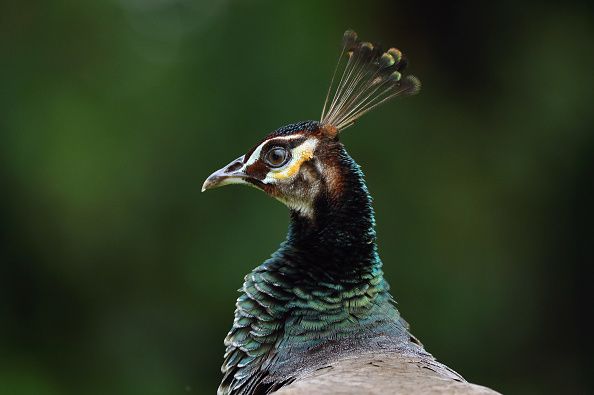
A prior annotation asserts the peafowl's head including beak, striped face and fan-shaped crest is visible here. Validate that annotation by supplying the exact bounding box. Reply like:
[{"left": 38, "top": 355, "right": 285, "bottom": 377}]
[{"left": 202, "top": 30, "right": 420, "bottom": 217}]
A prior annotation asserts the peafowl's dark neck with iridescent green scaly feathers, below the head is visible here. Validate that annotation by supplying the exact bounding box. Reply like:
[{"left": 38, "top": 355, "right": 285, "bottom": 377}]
[{"left": 219, "top": 150, "right": 409, "bottom": 393}]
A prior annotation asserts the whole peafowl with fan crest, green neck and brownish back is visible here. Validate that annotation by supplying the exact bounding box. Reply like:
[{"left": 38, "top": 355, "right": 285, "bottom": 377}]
[{"left": 202, "top": 30, "right": 496, "bottom": 395}]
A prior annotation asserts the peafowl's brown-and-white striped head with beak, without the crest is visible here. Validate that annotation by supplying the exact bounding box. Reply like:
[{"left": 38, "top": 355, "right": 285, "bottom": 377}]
[{"left": 202, "top": 121, "right": 341, "bottom": 216}]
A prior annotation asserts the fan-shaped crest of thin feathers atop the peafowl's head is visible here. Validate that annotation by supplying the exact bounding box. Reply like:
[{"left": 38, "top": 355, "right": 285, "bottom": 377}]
[{"left": 321, "top": 30, "right": 421, "bottom": 133}]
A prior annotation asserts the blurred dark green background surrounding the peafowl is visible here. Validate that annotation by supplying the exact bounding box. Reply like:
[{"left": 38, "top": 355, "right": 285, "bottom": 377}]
[{"left": 0, "top": 0, "right": 594, "bottom": 395}]
